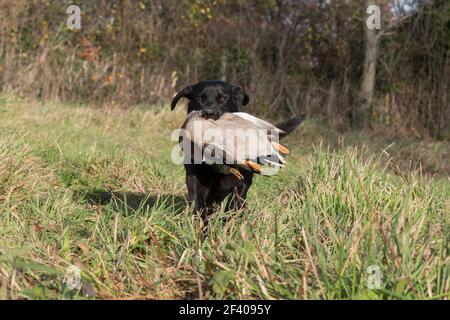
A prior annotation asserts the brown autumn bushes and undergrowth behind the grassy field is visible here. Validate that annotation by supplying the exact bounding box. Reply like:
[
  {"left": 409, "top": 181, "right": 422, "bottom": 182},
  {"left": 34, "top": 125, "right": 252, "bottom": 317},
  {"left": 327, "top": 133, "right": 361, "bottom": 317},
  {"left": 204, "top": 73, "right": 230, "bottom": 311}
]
[{"left": 0, "top": 0, "right": 450, "bottom": 138}]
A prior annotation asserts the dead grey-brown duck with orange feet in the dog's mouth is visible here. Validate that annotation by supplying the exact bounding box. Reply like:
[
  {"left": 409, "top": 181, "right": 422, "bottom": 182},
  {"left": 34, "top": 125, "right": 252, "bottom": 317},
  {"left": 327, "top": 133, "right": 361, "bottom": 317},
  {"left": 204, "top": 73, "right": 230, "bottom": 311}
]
[{"left": 180, "top": 111, "right": 289, "bottom": 179}]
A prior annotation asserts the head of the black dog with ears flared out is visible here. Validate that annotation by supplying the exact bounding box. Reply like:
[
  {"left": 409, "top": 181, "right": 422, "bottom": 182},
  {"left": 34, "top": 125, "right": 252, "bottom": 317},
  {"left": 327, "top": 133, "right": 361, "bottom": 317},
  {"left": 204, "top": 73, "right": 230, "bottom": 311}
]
[{"left": 171, "top": 80, "right": 250, "bottom": 120}]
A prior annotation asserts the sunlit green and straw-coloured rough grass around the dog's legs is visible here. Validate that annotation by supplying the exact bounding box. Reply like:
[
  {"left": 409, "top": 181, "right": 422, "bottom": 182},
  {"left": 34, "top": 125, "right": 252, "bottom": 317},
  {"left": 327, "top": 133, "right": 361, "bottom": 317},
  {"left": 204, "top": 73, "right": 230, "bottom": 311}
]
[{"left": 0, "top": 96, "right": 450, "bottom": 299}]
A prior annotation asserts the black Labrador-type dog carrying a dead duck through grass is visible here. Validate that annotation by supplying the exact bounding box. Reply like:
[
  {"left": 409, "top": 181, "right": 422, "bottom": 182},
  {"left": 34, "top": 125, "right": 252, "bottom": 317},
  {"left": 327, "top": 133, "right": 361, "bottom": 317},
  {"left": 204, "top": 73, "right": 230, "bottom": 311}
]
[{"left": 171, "top": 80, "right": 303, "bottom": 219}]
